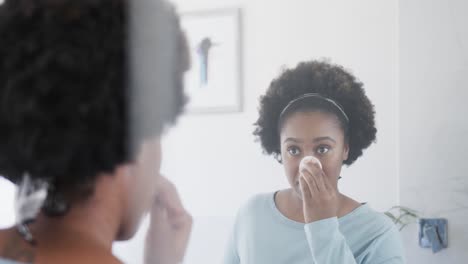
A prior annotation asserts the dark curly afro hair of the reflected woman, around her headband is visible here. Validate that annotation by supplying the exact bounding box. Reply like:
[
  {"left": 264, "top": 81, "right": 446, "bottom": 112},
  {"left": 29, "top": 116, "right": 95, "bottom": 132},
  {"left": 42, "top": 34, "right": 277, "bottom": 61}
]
[{"left": 253, "top": 60, "right": 377, "bottom": 165}]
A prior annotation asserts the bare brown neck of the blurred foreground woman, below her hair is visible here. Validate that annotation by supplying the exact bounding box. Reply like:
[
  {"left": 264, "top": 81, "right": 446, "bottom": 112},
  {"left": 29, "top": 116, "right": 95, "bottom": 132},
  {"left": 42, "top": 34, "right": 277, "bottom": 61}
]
[{"left": 31, "top": 176, "right": 122, "bottom": 251}]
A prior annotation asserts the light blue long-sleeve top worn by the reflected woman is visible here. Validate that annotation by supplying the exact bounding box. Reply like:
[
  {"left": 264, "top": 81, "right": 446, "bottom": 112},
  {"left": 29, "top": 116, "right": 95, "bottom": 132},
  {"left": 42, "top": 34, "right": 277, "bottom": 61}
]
[{"left": 224, "top": 193, "right": 405, "bottom": 264}]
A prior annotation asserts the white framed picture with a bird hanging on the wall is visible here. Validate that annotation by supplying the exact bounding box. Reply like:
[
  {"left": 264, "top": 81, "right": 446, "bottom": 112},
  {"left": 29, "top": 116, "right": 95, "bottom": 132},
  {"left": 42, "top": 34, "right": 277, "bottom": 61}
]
[{"left": 181, "top": 8, "right": 242, "bottom": 113}]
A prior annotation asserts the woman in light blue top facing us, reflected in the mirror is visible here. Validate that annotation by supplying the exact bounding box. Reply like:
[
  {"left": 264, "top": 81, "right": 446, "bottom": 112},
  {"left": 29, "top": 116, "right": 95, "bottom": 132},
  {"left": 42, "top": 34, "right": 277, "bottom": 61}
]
[{"left": 224, "top": 61, "right": 404, "bottom": 264}]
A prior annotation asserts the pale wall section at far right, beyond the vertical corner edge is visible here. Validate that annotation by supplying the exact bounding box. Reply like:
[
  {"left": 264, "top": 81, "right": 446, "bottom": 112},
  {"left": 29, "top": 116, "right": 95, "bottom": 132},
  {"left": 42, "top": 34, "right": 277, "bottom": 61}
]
[{"left": 399, "top": 0, "right": 468, "bottom": 264}]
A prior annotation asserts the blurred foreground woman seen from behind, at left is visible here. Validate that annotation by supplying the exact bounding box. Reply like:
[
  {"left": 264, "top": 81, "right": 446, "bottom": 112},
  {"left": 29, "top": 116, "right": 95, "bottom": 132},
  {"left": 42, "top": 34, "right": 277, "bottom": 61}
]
[{"left": 0, "top": 0, "right": 191, "bottom": 264}]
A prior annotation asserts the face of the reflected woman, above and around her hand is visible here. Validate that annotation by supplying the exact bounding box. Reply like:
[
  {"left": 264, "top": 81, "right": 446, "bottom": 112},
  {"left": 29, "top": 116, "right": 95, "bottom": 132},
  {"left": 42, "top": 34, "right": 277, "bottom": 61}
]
[{"left": 280, "top": 111, "right": 349, "bottom": 198}]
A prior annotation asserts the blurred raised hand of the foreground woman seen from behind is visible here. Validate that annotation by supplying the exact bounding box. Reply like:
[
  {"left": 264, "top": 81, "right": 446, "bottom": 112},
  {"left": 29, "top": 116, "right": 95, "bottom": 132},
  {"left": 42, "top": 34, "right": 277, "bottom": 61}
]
[{"left": 145, "top": 176, "right": 192, "bottom": 264}]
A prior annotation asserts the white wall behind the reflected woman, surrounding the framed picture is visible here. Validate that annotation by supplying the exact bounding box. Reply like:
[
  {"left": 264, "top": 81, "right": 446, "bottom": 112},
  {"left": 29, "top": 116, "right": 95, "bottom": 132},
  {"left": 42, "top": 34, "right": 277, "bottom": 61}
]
[{"left": 116, "top": 0, "right": 398, "bottom": 264}]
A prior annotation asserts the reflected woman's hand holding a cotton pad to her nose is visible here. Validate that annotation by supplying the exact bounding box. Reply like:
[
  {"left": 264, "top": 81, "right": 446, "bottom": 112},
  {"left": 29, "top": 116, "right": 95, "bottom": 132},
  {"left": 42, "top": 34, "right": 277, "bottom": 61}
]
[{"left": 299, "top": 161, "right": 339, "bottom": 223}]
